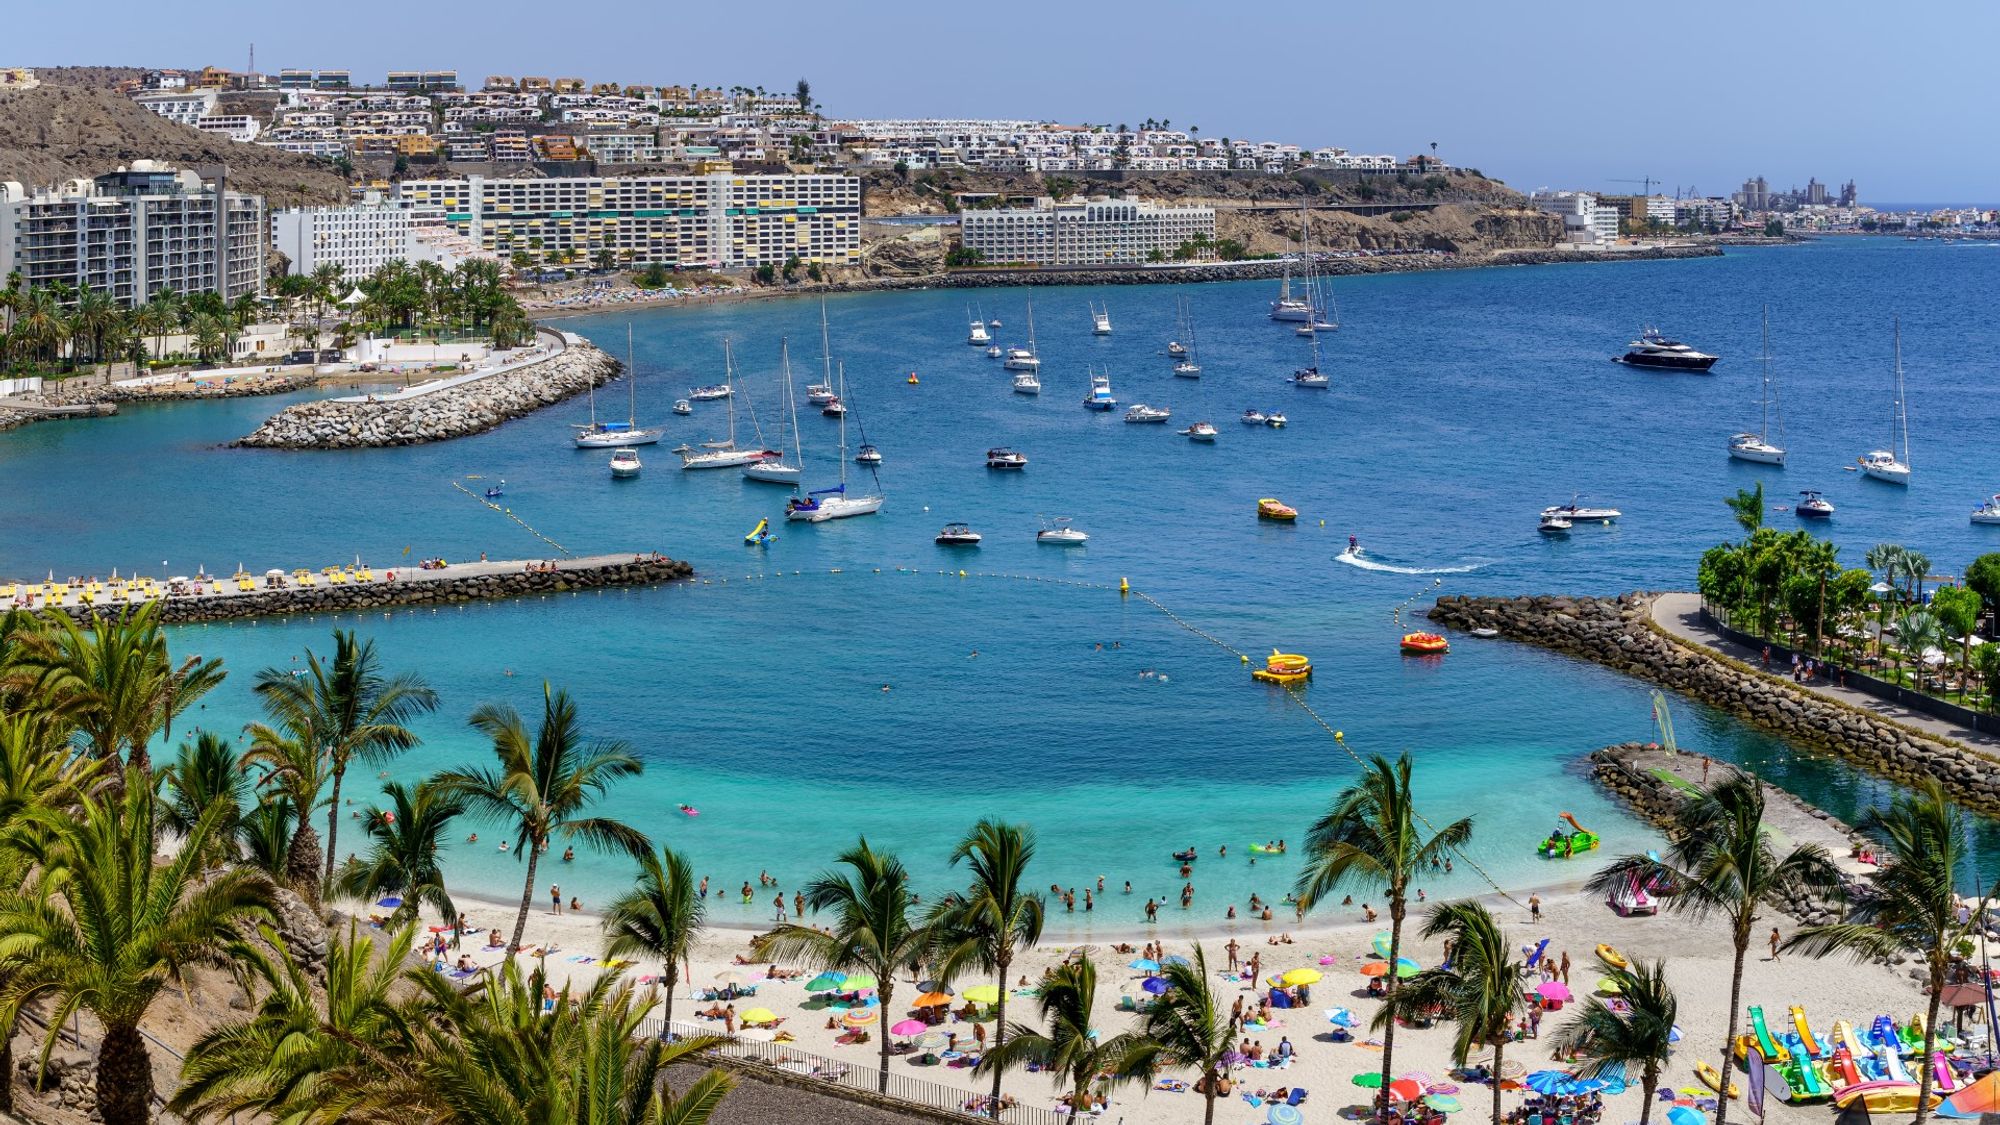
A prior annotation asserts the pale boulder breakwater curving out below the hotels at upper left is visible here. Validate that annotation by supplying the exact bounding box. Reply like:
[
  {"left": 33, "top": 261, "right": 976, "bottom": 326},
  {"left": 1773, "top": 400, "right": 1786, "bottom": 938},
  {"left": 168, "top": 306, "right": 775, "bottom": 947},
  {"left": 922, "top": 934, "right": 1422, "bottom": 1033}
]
[{"left": 230, "top": 336, "right": 622, "bottom": 448}]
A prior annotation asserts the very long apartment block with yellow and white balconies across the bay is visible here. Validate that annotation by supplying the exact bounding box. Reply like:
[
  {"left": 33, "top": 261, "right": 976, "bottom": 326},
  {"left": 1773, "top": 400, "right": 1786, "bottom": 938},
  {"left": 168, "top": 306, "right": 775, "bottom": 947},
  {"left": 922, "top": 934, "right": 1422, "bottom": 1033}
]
[{"left": 398, "top": 172, "right": 862, "bottom": 268}]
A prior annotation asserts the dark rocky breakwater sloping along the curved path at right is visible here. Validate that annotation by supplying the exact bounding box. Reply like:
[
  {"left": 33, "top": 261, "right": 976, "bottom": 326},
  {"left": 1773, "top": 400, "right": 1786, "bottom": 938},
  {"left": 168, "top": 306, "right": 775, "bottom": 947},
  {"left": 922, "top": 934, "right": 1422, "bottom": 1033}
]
[{"left": 1430, "top": 595, "right": 2000, "bottom": 811}]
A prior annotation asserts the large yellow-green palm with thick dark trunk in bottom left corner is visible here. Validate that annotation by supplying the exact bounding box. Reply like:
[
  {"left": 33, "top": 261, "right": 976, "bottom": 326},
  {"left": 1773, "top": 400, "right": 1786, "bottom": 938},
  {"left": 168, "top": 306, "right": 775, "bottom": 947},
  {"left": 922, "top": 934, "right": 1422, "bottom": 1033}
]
[{"left": 0, "top": 767, "right": 272, "bottom": 1125}]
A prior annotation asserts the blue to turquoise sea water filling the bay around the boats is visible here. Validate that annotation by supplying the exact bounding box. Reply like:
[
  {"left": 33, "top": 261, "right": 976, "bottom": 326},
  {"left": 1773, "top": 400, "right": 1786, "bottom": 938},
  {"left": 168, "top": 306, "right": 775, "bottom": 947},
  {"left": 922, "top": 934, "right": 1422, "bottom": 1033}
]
[{"left": 0, "top": 238, "right": 2000, "bottom": 925}]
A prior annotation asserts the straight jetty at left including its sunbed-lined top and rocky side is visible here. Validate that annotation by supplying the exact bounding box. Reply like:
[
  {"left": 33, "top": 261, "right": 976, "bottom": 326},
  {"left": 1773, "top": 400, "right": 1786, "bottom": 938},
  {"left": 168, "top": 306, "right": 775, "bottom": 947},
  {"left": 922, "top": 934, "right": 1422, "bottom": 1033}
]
[{"left": 21, "top": 554, "right": 694, "bottom": 625}]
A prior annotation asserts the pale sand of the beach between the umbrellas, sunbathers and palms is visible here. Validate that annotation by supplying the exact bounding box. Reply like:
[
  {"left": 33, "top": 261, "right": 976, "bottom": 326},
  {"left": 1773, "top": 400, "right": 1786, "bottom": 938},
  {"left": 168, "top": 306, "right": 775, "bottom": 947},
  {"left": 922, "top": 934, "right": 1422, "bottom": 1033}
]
[{"left": 414, "top": 840, "right": 1922, "bottom": 1125}]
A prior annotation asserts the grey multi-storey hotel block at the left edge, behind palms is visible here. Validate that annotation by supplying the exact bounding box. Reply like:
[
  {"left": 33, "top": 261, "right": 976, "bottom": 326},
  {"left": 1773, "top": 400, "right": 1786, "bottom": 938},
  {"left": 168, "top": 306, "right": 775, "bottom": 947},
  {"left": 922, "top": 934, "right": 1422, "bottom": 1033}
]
[{"left": 0, "top": 160, "right": 266, "bottom": 308}]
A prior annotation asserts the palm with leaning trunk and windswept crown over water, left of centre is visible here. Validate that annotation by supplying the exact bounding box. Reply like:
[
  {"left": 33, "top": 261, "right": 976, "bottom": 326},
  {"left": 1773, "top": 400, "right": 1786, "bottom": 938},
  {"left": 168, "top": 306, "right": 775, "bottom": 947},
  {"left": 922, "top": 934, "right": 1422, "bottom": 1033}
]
[{"left": 438, "top": 683, "right": 648, "bottom": 948}]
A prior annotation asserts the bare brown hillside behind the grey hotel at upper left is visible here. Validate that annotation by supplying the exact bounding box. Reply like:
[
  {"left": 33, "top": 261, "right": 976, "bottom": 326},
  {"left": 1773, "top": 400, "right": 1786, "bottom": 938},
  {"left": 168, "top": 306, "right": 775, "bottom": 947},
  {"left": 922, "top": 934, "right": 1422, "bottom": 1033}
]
[{"left": 0, "top": 86, "right": 348, "bottom": 208}]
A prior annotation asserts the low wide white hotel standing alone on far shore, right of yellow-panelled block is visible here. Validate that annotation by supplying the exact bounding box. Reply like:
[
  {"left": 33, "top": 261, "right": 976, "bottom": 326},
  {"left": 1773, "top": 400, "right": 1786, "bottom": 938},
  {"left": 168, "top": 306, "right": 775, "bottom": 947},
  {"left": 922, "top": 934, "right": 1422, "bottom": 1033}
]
[{"left": 960, "top": 196, "right": 1216, "bottom": 266}]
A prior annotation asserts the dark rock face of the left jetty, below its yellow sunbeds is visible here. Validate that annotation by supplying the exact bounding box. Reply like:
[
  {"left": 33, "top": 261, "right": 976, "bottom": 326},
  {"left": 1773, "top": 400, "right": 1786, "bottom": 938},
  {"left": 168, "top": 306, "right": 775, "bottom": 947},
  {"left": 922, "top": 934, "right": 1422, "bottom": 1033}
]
[{"left": 45, "top": 554, "right": 694, "bottom": 625}]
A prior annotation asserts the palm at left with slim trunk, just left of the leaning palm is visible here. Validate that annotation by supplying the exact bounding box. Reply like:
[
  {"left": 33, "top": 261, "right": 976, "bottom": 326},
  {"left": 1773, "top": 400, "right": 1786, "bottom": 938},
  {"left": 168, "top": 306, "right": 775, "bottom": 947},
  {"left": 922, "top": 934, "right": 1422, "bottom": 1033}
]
[{"left": 254, "top": 629, "right": 438, "bottom": 895}]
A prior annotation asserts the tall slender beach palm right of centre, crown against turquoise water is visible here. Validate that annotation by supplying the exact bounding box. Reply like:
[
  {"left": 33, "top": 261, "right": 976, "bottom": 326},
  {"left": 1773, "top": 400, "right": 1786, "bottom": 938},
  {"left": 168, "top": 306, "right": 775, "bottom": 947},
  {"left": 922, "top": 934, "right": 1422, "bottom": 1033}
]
[{"left": 1296, "top": 755, "right": 1472, "bottom": 1089}]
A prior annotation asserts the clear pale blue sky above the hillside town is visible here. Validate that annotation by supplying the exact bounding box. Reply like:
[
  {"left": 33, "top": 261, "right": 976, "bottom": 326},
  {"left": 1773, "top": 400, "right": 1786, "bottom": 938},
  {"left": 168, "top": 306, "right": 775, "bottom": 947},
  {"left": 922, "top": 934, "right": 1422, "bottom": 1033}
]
[{"left": 19, "top": 0, "right": 2000, "bottom": 200}]
